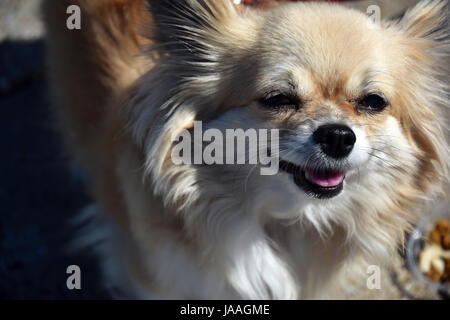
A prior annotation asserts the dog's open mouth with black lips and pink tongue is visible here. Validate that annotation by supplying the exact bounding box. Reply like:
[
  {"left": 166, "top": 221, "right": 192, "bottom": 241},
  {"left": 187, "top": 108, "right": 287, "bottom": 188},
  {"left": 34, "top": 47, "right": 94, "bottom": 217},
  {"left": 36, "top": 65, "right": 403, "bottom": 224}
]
[{"left": 280, "top": 160, "right": 345, "bottom": 199}]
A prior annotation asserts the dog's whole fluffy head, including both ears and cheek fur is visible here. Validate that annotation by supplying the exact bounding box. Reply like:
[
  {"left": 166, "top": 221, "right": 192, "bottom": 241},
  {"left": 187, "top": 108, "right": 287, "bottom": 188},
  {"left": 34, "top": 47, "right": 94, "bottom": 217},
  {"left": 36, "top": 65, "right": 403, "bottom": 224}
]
[{"left": 130, "top": 0, "right": 448, "bottom": 248}]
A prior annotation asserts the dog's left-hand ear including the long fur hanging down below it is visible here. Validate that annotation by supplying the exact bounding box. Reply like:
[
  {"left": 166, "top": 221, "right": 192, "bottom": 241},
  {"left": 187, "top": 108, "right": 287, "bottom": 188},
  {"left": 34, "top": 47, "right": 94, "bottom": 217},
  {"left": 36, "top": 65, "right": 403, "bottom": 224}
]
[{"left": 128, "top": 0, "right": 256, "bottom": 168}]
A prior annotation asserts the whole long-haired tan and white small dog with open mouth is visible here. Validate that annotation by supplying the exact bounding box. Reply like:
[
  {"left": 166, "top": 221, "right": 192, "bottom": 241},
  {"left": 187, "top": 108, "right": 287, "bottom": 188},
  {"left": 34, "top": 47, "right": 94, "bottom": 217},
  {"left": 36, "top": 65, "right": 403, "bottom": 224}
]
[{"left": 44, "top": 0, "right": 449, "bottom": 299}]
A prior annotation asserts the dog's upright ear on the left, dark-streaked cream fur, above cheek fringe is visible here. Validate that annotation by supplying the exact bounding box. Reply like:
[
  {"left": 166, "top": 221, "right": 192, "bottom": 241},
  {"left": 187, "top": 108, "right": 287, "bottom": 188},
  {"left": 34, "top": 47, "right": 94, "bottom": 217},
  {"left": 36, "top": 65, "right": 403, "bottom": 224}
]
[{"left": 142, "top": 0, "right": 255, "bottom": 109}]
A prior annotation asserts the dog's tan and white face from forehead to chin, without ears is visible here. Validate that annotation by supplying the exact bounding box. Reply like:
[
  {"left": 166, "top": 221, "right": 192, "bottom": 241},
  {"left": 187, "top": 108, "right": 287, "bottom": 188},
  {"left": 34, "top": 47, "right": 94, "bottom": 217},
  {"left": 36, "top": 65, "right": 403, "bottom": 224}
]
[{"left": 223, "top": 5, "right": 406, "bottom": 199}]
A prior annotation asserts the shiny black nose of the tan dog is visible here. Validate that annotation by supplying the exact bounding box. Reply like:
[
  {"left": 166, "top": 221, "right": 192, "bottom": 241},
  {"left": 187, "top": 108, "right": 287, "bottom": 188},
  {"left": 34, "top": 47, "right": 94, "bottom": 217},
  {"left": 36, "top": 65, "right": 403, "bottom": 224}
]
[{"left": 313, "top": 124, "right": 356, "bottom": 159}]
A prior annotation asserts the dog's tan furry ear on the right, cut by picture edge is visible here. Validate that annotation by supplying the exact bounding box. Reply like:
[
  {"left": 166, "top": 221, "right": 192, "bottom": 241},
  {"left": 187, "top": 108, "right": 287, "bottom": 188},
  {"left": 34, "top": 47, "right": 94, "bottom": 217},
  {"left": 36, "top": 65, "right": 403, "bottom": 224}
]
[{"left": 393, "top": 0, "right": 450, "bottom": 192}]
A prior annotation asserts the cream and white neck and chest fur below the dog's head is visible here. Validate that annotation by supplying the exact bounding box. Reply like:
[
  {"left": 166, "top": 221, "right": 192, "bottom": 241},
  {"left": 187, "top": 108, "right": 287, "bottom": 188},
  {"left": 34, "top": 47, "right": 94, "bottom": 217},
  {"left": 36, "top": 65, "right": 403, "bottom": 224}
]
[{"left": 112, "top": 144, "right": 390, "bottom": 299}]
